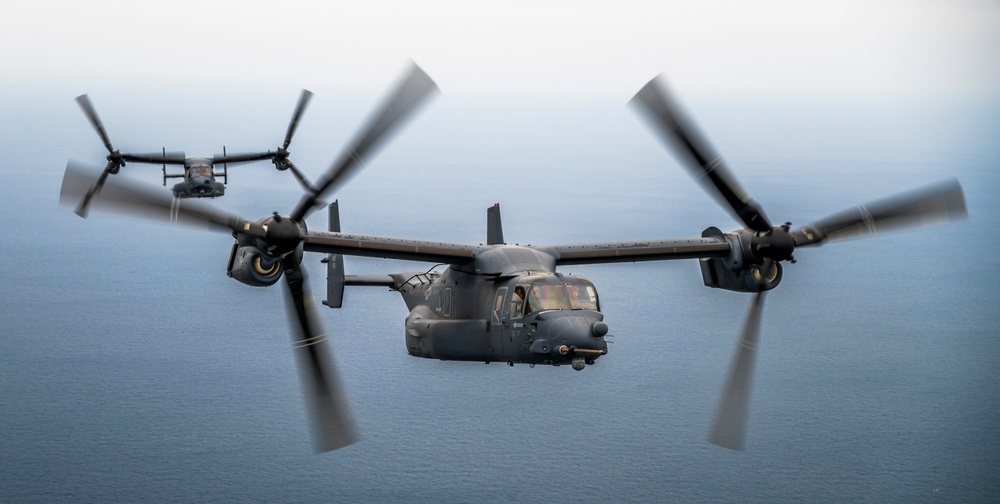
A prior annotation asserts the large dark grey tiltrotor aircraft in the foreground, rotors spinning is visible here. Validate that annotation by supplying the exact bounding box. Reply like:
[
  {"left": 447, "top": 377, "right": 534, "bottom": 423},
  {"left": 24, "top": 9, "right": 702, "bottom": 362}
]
[{"left": 61, "top": 66, "right": 966, "bottom": 451}]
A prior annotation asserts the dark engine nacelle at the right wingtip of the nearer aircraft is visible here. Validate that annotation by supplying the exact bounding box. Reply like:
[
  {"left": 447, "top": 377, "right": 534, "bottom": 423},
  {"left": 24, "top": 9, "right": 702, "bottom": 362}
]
[{"left": 699, "top": 227, "right": 781, "bottom": 292}]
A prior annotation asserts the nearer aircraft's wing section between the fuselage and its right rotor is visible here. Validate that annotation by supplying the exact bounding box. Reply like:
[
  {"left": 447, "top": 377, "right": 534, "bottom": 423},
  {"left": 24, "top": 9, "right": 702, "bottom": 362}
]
[{"left": 537, "top": 237, "right": 730, "bottom": 266}]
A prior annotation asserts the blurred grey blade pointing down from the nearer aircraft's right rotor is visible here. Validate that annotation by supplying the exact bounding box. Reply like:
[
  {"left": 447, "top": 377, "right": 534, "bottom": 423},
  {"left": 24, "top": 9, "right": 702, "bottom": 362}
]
[{"left": 708, "top": 292, "right": 764, "bottom": 450}]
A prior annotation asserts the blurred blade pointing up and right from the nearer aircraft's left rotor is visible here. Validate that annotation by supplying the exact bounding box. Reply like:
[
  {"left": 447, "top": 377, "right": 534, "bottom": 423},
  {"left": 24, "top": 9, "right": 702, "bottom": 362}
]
[{"left": 291, "top": 64, "right": 438, "bottom": 222}]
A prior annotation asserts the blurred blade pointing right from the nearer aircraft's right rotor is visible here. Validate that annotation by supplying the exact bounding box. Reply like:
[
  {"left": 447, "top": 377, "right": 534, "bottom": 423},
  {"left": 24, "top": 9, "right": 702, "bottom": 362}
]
[{"left": 792, "top": 179, "right": 969, "bottom": 247}]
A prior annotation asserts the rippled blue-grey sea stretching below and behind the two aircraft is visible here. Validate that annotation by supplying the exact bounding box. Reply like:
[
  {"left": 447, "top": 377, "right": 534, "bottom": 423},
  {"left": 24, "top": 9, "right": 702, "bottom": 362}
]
[{"left": 0, "top": 93, "right": 1000, "bottom": 503}]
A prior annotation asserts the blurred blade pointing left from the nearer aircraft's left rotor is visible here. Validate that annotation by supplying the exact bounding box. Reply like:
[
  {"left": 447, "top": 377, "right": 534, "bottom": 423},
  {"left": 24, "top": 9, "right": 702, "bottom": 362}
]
[{"left": 59, "top": 161, "right": 265, "bottom": 237}]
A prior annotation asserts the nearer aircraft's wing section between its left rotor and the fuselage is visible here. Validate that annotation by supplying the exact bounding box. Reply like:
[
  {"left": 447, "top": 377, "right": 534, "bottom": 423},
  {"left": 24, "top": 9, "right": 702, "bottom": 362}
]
[{"left": 304, "top": 231, "right": 487, "bottom": 264}]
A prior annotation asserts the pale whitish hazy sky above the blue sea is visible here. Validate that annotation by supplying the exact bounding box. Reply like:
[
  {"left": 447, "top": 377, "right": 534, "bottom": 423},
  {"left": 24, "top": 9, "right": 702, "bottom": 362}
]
[{"left": 0, "top": 0, "right": 1000, "bottom": 102}]
